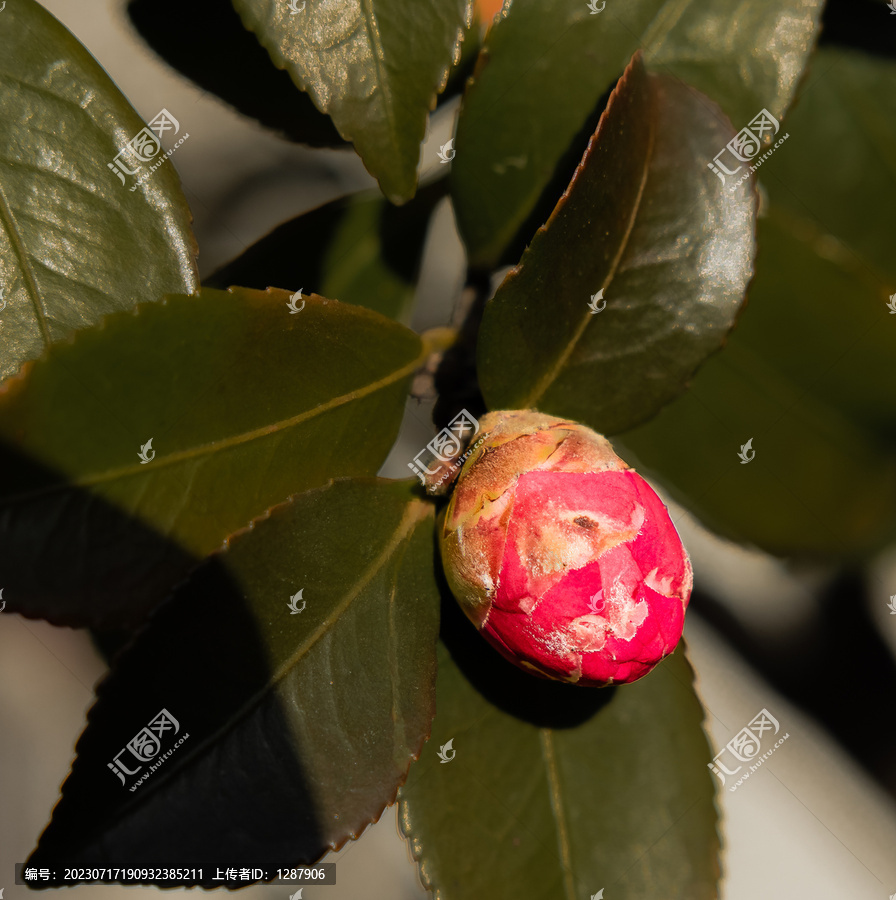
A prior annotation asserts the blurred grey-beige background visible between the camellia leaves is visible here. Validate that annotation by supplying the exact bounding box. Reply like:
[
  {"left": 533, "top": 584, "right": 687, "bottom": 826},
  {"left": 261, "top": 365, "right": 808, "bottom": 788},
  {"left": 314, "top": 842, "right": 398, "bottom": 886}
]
[{"left": 0, "top": 0, "right": 896, "bottom": 900}]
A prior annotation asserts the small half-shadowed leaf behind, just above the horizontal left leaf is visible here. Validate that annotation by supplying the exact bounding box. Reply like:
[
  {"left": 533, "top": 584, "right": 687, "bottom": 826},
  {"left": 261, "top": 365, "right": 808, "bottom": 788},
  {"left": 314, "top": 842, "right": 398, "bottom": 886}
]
[{"left": 206, "top": 178, "right": 446, "bottom": 324}]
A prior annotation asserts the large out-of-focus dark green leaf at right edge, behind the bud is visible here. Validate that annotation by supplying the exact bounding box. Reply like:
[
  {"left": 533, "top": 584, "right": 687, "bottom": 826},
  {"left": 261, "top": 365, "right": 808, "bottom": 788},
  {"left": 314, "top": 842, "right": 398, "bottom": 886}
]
[{"left": 620, "top": 50, "right": 896, "bottom": 559}]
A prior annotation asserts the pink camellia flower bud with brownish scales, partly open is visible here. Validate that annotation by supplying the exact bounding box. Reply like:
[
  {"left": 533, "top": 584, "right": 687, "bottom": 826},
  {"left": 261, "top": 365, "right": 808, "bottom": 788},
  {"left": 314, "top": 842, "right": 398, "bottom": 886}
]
[{"left": 439, "top": 410, "right": 693, "bottom": 686}]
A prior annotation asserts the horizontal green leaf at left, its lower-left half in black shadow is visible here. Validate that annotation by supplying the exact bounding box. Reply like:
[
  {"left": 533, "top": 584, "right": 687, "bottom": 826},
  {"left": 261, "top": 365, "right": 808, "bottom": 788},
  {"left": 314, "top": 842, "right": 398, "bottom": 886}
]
[{"left": 0, "top": 288, "right": 422, "bottom": 627}]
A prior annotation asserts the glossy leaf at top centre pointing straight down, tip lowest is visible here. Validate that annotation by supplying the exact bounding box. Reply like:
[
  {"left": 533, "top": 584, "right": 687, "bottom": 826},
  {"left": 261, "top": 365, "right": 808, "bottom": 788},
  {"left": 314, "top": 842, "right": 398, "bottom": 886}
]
[{"left": 233, "top": 0, "right": 472, "bottom": 203}]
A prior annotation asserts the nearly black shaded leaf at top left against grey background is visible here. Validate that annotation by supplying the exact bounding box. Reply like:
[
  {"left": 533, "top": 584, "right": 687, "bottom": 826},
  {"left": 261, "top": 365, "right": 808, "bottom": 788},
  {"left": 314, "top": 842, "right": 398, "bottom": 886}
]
[{"left": 128, "top": 0, "right": 346, "bottom": 148}]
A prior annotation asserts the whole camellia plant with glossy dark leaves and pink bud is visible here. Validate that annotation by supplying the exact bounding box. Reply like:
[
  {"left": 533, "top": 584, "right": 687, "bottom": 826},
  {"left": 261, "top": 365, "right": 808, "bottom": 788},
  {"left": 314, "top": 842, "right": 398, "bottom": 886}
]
[{"left": 0, "top": 0, "right": 896, "bottom": 900}]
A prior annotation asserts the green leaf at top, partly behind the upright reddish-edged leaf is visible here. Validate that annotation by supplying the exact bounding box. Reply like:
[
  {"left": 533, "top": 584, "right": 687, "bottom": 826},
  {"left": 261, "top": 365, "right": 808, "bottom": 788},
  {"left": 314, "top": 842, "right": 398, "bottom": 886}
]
[{"left": 452, "top": 0, "right": 824, "bottom": 268}]
